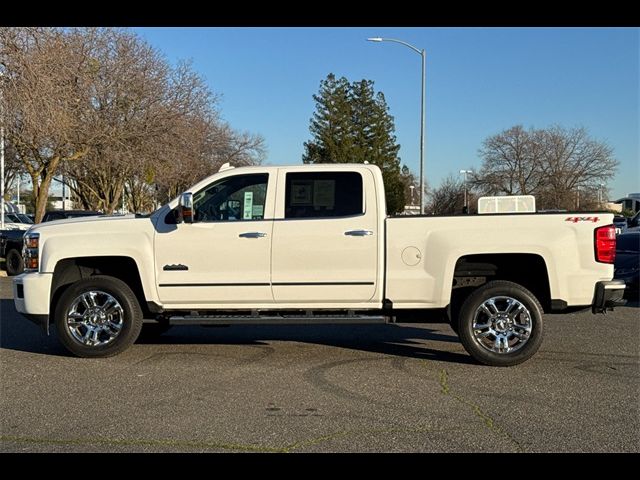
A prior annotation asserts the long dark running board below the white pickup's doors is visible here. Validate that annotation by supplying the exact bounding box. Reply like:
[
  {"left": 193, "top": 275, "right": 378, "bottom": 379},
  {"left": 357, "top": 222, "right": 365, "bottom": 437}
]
[{"left": 169, "top": 315, "right": 387, "bottom": 325}]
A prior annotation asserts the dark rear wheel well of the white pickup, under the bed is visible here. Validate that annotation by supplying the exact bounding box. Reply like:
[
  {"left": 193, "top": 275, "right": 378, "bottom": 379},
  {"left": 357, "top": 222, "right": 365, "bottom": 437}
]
[{"left": 451, "top": 253, "right": 551, "bottom": 318}]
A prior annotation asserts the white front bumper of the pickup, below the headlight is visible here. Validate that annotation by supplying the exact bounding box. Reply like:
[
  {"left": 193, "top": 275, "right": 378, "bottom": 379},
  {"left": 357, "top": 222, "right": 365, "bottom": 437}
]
[{"left": 13, "top": 273, "right": 53, "bottom": 335}]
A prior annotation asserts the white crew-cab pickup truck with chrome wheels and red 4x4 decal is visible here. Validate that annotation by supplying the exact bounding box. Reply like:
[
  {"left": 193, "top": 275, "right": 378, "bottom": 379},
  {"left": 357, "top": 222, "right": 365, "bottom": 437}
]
[{"left": 13, "top": 164, "right": 625, "bottom": 366}]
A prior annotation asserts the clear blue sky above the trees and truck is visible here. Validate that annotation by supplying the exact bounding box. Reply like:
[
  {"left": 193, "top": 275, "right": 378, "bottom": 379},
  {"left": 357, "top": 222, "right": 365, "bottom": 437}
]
[{"left": 134, "top": 27, "right": 640, "bottom": 199}]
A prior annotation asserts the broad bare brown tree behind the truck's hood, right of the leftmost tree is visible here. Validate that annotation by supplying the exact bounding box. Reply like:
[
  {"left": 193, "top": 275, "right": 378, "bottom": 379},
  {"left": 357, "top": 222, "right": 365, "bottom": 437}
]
[{"left": 65, "top": 29, "right": 264, "bottom": 212}]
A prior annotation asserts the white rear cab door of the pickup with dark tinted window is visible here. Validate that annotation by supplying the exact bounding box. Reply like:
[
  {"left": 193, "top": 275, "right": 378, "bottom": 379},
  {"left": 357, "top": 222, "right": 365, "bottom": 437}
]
[{"left": 271, "top": 167, "right": 383, "bottom": 306}]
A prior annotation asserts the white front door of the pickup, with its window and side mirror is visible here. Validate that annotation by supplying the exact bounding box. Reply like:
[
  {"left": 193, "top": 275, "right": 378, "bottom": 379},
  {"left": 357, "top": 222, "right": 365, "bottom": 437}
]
[{"left": 155, "top": 171, "right": 275, "bottom": 308}]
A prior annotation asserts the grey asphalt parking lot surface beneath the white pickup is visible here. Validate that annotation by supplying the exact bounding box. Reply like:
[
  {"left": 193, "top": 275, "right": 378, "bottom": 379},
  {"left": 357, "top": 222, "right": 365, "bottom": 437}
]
[{"left": 0, "top": 277, "right": 640, "bottom": 452}]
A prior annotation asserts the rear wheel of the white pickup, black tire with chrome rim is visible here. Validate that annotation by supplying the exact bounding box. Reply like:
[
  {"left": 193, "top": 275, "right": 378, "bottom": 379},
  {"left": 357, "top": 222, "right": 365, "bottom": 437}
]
[{"left": 458, "top": 280, "right": 544, "bottom": 367}]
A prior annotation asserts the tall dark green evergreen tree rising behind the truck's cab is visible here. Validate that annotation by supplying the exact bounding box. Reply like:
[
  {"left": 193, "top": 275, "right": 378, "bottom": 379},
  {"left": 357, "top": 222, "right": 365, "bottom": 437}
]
[{"left": 302, "top": 74, "right": 405, "bottom": 214}]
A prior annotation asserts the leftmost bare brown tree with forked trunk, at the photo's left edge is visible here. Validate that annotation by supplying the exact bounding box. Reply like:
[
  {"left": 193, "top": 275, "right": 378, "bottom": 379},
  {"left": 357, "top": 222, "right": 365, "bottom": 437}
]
[{"left": 0, "top": 27, "right": 97, "bottom": 221}]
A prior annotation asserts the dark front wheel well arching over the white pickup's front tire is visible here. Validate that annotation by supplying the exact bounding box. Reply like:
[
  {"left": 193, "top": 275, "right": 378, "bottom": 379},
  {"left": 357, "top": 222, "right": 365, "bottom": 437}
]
[{"left": 49, "top": 256, "right": 149, "bottom": 321}]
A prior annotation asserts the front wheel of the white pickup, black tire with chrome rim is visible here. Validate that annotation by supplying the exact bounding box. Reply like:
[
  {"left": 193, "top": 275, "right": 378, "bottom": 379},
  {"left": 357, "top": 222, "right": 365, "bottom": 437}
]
[{"left": 54, "top": 275, "right": 142, "bottom": 358}]
